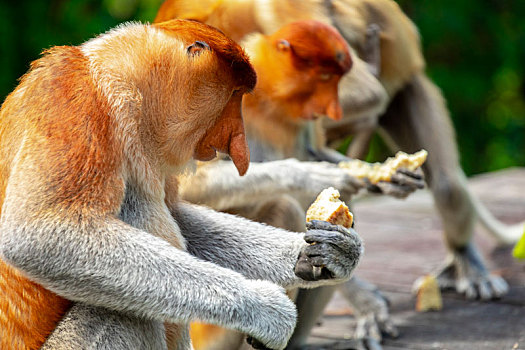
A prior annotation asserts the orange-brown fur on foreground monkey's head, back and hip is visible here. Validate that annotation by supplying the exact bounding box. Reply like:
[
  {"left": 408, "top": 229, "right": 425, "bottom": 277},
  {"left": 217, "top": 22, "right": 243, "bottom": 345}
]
[{"left": 0, "top": 20, "right": 255, "bottom": 350}]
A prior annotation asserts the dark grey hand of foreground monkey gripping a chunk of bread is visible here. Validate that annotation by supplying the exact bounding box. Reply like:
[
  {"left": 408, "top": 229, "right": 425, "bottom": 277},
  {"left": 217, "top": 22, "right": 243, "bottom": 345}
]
[{"left": 295, "top": 220, "right": 363, "bottom": 283}]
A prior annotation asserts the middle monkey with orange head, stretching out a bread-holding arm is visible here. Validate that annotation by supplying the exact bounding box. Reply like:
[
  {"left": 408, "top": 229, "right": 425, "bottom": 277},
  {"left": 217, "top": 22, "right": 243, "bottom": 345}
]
[{"left": 174, "top": 21, "right": 422, "bottom": 349}]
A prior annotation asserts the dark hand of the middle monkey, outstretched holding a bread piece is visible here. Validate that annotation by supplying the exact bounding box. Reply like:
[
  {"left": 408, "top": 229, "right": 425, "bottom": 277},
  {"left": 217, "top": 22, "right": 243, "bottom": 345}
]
[{"left": 365, "top": 168, "right": 425, "bottom": 198}]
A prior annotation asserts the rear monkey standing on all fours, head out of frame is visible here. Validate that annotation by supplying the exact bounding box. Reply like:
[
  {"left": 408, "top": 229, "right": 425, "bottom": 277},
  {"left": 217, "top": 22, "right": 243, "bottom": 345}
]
[{"left": 157, "top": 0, "right": 522, "bottom": 300}]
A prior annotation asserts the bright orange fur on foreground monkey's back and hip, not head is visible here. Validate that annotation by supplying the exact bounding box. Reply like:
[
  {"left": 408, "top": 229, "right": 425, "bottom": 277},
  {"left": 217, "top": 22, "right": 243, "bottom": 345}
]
[{"left": 0, "top": 47, "right": 118, "bottom": 349}]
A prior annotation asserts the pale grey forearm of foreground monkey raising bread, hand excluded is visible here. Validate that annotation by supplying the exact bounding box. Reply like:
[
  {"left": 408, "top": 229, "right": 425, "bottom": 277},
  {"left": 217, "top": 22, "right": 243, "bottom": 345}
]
[{"left": 173, "top": 203, "right": 334, "bottom": 288}]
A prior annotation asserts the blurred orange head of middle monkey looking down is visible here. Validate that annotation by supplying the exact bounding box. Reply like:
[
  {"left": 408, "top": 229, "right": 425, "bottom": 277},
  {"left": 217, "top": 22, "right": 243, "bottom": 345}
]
[{"left": 254, "top": 21, "right": 352, "bottom": 122}]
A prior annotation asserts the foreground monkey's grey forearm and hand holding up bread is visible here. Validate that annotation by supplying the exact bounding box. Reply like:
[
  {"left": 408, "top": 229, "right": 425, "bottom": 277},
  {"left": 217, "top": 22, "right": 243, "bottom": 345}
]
[{"left": 172, "top": 202, "right": 362, "bottom": 289}]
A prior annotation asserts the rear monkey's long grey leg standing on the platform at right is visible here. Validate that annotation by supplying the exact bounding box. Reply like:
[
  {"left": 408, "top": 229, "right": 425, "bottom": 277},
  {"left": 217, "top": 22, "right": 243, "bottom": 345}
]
[{"left": 380, "top": 75, "right": 508, "bottom": 299}]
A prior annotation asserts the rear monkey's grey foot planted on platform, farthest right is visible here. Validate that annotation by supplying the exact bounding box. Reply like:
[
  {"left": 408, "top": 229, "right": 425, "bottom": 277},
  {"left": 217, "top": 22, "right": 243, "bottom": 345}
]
[{"left": 414, "top": 243, "right": 509, "bottom": 300}]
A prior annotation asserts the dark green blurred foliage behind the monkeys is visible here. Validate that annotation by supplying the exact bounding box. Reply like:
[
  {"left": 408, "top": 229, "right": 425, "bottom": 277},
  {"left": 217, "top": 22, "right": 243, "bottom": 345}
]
[{"left": 0, "top": 0, "right": 525, "bottom": 175}]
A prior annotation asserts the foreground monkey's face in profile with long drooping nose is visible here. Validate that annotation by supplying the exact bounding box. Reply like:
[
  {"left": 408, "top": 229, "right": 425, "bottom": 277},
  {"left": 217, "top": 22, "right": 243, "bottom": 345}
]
[{"left": 151, "top": 20, "right": 256, "bottom": 175}]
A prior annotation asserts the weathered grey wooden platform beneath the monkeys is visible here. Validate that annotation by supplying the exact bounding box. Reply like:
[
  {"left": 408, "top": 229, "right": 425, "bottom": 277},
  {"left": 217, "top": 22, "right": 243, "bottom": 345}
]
[{"left": 310, "top": 168, "right": 525, "bottom": 350}]
